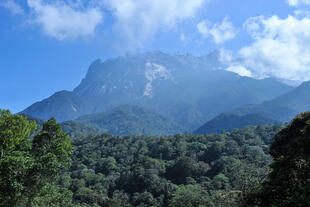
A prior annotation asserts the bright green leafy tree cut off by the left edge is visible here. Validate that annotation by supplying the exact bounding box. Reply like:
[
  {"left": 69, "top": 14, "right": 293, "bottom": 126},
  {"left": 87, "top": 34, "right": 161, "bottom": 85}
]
[{"left": 0, "top": 110, "right": 36, "bottom": 206}]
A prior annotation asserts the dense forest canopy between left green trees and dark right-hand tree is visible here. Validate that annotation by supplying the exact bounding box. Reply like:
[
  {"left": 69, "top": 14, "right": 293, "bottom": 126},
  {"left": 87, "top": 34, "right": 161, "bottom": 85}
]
[{"left": 70, "top": 125, "right": 281, "bottom": 207}]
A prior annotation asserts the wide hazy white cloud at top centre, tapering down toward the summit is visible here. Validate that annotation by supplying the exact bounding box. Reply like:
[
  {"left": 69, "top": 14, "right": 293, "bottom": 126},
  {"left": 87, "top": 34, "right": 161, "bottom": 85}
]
[{"left": 102, "top": 0, "right": 208, "bottom": 47}]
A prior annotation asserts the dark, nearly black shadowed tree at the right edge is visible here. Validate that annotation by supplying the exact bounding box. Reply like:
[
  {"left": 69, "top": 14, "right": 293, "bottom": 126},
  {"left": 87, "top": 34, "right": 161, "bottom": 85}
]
[{"left": 245, "top": 113, "right": 310, "bottom": 207}]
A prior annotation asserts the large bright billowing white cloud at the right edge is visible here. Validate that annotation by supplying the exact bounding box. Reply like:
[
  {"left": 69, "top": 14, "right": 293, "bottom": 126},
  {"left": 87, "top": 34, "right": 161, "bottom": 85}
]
[{"left": 239, "top": 15, "right": 310, "bottom": 82}]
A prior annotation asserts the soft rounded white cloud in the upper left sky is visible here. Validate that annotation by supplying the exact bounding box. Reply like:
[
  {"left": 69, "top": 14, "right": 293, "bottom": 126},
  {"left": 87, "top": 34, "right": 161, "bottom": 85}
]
[{"left": 27, "top": 0, "right": 103, "bottom": 40}]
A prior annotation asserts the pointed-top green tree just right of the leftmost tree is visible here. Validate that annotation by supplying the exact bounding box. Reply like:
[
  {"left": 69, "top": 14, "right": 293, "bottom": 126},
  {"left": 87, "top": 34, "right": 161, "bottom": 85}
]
[{"left": 29, "top": 118, "right": 72, "bottom": 206}]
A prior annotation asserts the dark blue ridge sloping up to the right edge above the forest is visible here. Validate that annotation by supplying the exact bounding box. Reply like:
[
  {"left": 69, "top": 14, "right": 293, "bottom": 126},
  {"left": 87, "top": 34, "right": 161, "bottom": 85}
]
[{"left": 196, "top": 82, "right": 310, "bottom": 133}]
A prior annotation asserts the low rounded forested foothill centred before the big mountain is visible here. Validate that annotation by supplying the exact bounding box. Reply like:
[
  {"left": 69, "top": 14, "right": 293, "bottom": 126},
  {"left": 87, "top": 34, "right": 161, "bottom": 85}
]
[{"left": 76, "top": 105, "right": 184, "bottom": 135}]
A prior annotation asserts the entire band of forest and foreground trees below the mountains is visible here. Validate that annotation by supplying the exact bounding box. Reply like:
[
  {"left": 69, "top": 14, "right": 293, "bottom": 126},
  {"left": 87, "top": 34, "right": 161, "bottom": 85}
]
[{"left": 0, "top": 111, "right": 310, "bottom": 207}]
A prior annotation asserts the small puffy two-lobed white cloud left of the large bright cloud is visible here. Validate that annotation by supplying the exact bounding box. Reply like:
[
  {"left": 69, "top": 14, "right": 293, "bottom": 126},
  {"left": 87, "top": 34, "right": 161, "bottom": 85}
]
[{"left": 197, "top": 18, "right": 237, "bottom": 44}]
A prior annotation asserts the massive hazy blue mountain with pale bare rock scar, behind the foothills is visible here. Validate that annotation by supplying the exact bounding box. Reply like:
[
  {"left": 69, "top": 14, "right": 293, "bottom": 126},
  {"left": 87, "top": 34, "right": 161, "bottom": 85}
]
[{"left": 22, "top": 51, "right": 292, "bottom": 131}]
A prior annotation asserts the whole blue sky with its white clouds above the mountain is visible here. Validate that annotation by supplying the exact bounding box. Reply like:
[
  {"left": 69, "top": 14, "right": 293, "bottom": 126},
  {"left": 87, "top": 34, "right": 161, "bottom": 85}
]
[{"left": 0, "top": 0, "right": 310, "bottom": 112}]
